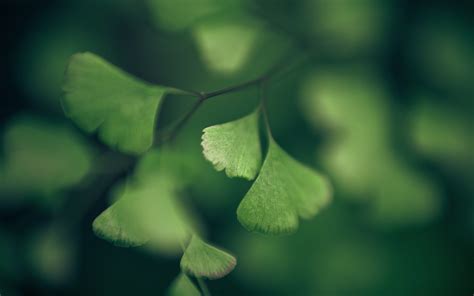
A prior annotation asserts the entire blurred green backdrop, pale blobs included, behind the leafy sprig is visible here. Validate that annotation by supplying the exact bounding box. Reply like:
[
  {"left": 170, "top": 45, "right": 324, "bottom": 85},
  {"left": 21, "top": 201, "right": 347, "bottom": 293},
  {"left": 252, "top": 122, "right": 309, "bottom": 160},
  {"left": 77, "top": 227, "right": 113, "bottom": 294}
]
[{"left": 0, "top": 0, "right": 474, "bottom": 296}]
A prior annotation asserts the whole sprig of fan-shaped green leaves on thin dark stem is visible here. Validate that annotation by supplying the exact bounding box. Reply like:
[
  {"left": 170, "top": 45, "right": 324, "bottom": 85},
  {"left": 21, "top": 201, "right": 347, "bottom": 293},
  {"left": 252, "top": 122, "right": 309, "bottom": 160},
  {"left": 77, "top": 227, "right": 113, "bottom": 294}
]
[{"left": 62, "top": 48, "right": 331, "bottom": 295}]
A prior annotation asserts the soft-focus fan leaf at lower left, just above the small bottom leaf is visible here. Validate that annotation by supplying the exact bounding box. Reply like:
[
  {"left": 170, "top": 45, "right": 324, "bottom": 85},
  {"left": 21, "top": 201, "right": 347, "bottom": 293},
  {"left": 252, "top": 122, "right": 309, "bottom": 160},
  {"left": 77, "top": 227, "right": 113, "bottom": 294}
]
[{"left": 93, "top": 151, "right": 194, "bottom": 253}]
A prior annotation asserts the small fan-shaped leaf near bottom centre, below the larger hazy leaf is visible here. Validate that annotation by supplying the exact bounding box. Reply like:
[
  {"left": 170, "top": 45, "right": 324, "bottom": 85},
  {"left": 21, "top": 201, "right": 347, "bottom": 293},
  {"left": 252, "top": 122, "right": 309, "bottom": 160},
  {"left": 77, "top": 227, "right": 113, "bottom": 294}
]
[{"left": 181, "top": 235, "right": 237, "bottom": 279}]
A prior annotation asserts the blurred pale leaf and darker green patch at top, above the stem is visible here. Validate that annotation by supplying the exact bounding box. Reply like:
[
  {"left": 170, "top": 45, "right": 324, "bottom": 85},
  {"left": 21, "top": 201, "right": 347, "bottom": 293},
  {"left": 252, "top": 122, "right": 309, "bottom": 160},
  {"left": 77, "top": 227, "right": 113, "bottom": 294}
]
[{"left": 147, "top": 0, "right": 288, "bottom": 75}]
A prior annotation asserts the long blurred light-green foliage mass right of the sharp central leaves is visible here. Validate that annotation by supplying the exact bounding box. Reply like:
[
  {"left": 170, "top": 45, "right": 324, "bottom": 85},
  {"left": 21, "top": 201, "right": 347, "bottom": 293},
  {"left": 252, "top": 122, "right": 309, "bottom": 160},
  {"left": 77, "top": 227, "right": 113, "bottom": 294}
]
[{"left": 302, "top": 69, "right": 440, "bottom": 226}]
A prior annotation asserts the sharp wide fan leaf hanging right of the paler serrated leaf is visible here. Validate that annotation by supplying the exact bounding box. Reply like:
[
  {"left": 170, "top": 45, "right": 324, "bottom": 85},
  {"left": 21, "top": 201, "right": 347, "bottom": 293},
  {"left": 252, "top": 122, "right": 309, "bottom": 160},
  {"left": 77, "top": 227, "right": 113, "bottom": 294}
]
[{"left": 237, "top": 137, "right": 331, "bottom": 235}]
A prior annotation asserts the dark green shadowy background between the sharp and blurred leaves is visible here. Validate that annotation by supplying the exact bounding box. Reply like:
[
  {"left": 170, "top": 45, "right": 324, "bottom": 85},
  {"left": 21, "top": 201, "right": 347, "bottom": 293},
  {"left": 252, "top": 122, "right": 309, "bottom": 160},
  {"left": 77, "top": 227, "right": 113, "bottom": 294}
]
[{"left": 0, "top": 0, "right": 474, "bottom": 296}]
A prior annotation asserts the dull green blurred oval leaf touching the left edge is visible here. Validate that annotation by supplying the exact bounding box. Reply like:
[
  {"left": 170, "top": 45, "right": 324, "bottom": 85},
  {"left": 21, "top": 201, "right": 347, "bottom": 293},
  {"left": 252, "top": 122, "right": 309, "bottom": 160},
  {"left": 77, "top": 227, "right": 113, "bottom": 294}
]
[{"left": 0, "top": 116, "right": 92, "bottom": 206}]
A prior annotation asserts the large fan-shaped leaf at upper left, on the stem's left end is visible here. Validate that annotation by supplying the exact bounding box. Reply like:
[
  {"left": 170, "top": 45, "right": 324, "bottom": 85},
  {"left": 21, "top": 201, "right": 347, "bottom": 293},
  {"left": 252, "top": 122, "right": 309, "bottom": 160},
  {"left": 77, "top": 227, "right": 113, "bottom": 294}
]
[{"left": 63, "top": 53, "right": 166, "bottom": 154}]
